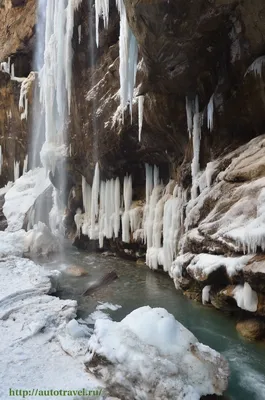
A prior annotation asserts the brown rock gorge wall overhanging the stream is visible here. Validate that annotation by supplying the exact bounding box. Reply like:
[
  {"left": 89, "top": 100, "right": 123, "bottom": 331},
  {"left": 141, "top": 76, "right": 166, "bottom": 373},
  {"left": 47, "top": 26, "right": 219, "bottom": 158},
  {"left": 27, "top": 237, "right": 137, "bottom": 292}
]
[{"left": 0, "top": 0, "right": 265, "bottom": 338}]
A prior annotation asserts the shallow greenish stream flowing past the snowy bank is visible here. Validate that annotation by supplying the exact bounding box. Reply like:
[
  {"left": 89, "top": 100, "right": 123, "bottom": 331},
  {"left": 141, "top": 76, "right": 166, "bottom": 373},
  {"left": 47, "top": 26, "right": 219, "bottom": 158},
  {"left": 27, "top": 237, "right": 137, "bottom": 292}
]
[{"left": 40, "top": 247, "right": 265, "bottom": 400}]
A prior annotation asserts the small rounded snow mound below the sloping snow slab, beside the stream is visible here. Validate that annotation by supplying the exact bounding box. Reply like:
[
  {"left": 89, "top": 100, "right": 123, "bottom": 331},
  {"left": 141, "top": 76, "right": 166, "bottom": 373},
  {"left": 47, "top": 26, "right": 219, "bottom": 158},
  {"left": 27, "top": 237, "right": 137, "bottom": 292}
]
[{"left": 25, "top": 222, "right": 61, "bottom": 256}]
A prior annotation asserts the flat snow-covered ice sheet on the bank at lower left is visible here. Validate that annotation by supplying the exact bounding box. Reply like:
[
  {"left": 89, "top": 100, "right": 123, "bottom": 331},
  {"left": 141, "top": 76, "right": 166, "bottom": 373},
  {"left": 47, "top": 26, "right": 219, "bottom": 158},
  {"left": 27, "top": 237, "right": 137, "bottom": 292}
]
[{"left": 0, "top": 255, "right": 102, "bottom": 400}]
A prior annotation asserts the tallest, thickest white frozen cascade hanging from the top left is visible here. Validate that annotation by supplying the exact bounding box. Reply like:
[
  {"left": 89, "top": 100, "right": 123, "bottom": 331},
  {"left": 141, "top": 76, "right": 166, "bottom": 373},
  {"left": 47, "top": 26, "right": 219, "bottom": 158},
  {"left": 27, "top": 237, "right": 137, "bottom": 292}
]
[{"left": 39, "top": 0, "right": 80, "bottom": 170}]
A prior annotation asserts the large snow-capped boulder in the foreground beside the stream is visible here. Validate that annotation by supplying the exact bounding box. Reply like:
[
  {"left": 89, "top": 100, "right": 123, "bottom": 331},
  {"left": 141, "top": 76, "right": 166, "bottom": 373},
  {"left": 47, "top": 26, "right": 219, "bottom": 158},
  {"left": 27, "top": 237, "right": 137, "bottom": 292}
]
[{"left": 87, "top": 306, "right": 229, "bottom": 400}]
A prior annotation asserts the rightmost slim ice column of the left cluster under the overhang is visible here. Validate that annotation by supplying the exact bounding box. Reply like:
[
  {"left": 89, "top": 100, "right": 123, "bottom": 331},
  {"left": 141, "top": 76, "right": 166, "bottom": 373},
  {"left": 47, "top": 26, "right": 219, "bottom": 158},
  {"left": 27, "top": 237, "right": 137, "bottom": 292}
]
[{"left": 122, "top": 176, "right": 132, "bottom": 243}]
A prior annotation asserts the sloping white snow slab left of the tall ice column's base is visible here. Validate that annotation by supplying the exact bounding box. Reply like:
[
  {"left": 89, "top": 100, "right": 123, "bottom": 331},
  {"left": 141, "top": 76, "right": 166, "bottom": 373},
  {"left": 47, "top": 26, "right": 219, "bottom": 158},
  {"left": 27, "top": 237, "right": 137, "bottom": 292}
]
[{"left": 3, "top": 168, "right": 51, "bottom": 232}]
